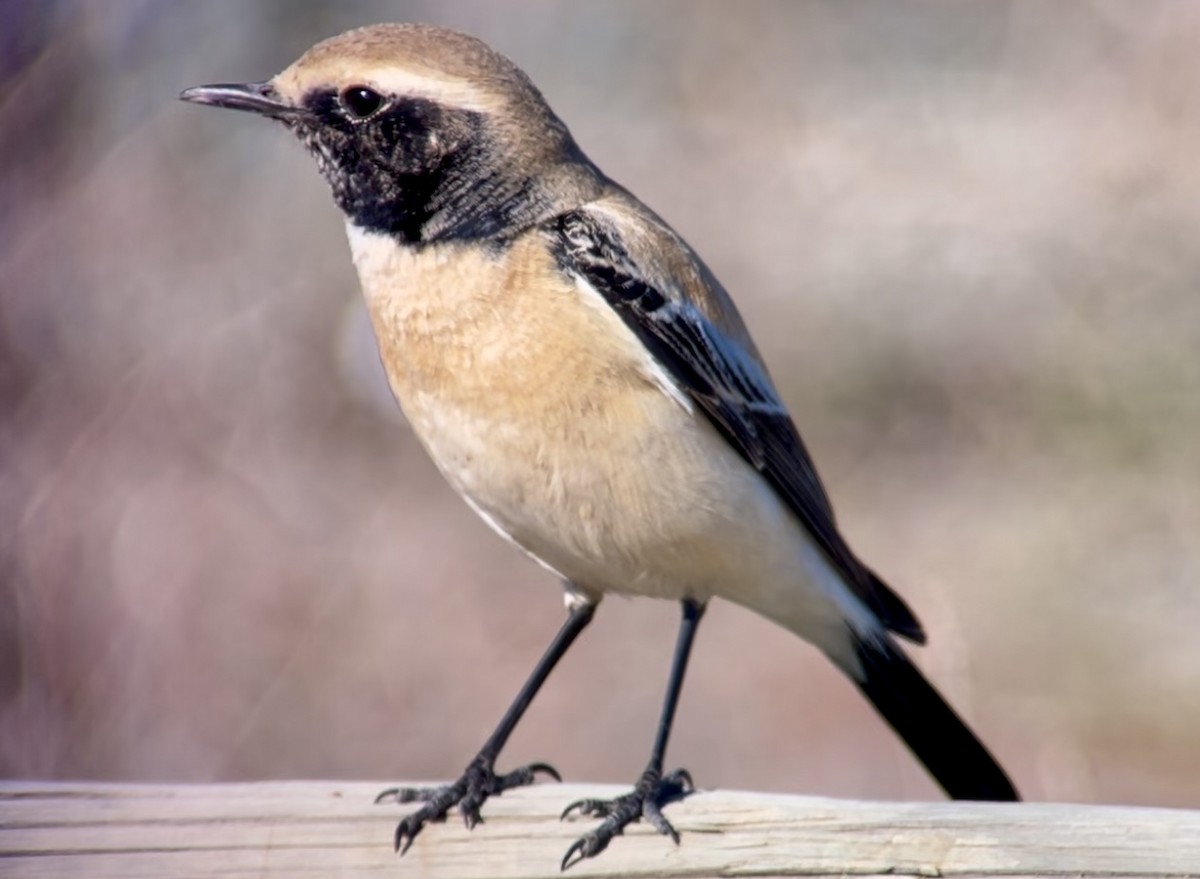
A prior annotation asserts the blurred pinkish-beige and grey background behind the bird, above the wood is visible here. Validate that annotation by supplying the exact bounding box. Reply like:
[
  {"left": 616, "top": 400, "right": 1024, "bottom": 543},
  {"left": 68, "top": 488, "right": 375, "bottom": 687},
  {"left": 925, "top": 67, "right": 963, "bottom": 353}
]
[{"left": 0, "top": 0, "right": 1200, "bottom": 807}]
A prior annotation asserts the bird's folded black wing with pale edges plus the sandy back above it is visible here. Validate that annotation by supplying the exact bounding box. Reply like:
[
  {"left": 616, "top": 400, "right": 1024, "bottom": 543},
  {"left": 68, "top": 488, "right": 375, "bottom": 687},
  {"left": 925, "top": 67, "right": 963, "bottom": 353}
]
[{"left": 546, "top": 193, "right": 924, "bottom": 642}]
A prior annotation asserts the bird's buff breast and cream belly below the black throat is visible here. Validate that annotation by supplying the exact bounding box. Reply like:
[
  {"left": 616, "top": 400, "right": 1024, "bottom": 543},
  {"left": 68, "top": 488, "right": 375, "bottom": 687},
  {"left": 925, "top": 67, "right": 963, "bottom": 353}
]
[{"left": 350, "top": 227, "right": 793, "bottom": 597}]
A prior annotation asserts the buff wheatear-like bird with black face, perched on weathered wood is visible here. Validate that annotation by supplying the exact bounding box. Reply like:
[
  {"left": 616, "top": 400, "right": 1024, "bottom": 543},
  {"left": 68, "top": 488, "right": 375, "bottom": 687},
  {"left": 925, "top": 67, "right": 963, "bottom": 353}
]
[{"left": 181, "top": 24, "right": 1018, "bottom": 868}]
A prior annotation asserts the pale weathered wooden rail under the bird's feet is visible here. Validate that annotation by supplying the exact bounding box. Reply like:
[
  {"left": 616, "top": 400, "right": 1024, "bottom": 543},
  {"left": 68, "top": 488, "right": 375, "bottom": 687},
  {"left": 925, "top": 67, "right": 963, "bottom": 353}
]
[{"left": 0, "top": 782, "right": 1200, "bottom": 879}]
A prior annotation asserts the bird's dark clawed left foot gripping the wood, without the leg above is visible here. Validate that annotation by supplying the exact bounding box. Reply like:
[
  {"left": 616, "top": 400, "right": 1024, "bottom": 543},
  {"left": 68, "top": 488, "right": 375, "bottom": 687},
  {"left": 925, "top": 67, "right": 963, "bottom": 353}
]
[{"left": 376, "top": 755, "right": 563, "bottom": 855}]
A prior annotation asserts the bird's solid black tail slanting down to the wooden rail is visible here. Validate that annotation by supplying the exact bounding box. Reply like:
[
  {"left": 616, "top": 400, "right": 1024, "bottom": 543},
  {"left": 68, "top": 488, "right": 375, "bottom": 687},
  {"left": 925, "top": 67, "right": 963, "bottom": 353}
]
[{"left": 854, "top": 639, "right": 1021, "bottom": 801}]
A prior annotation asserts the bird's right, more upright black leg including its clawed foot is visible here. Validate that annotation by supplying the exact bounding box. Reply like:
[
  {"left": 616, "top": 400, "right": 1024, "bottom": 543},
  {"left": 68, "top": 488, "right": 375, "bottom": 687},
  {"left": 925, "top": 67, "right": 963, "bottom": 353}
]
[{"left": 562, "top": 599, "right": 704, "bottom": 869}]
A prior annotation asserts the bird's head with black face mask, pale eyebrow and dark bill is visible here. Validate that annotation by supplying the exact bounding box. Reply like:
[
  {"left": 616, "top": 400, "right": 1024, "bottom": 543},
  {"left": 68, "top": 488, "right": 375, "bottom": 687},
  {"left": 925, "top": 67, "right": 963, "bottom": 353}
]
[{"left": 180, "top": 24, "right": 599, "bottom": 243}]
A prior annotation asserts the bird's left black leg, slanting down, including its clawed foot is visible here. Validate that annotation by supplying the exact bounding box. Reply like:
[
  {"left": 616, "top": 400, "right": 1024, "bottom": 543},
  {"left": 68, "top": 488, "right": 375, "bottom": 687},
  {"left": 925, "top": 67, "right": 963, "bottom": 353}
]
[{"left": 376, "top": 604, "right": 595, "bottom": 854}]
